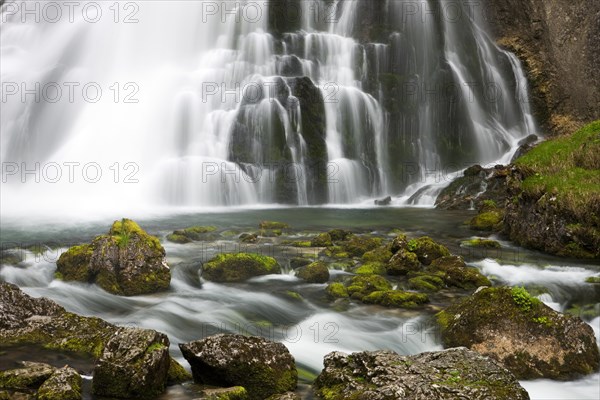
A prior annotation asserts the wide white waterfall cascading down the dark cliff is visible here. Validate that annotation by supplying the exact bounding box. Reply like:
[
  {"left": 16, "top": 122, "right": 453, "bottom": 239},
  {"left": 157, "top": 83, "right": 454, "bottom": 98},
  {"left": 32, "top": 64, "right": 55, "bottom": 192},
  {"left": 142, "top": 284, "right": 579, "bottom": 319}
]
[{"left": 0, "top": 0, "right": 536, "bottom": 217}]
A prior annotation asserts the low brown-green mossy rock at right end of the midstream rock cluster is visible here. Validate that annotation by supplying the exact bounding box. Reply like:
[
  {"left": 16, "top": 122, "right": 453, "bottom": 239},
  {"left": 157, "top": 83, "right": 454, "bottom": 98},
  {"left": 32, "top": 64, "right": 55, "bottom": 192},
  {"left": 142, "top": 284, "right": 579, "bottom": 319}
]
[{"left": 427, "top": 256, "right": 491, "bottom": 289}]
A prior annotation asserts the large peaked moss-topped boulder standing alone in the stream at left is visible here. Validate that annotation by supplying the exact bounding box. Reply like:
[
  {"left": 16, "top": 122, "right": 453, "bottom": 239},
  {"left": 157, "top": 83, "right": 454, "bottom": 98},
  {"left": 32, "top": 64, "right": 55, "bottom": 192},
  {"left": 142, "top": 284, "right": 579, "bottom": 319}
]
[{"left": 56, "top": 219, "right": 171, "bottom": 296}]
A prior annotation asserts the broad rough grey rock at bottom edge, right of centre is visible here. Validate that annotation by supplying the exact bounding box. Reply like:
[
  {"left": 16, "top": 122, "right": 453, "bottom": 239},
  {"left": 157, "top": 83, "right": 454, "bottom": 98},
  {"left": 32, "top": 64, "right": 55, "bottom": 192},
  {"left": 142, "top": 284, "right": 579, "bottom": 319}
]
[{"left": 314, "top": 348, "right": 529, "bottom": 400}]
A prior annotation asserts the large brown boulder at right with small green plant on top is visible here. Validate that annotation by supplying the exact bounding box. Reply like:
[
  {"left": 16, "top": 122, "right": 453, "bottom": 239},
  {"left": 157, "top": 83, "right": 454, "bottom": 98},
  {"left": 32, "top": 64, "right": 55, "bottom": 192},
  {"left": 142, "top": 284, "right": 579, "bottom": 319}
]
[{"left": 436, "top": 287, "right": 600, "bottom": 379}]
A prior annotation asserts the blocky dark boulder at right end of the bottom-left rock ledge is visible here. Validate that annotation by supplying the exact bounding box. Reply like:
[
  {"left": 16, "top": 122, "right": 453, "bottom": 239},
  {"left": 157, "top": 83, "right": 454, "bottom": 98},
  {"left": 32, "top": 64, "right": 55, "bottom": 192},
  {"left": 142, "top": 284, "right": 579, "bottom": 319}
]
[{"left": 92, "top": 328, "right": 171, "bottom": 399}]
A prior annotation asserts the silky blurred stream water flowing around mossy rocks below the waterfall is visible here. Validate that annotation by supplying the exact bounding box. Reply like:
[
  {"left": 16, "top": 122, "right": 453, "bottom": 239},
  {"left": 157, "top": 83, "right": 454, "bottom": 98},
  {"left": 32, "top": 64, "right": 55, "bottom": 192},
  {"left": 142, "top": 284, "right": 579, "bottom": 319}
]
[{"left": 0, "top": 208, "right": 600, "bottom": 400}]
